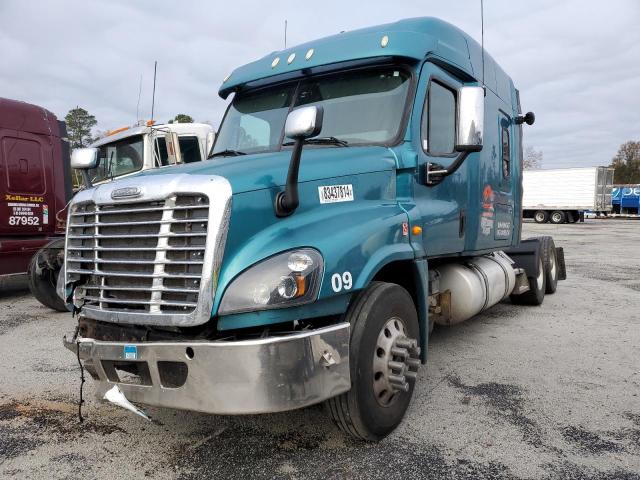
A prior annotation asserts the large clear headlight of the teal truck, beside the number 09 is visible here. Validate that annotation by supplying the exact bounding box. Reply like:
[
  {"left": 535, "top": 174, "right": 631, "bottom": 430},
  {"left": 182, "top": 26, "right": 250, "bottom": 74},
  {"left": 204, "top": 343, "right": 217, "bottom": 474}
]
[{"left": 219, "top": 248, "right": 323, "bottom": 315}]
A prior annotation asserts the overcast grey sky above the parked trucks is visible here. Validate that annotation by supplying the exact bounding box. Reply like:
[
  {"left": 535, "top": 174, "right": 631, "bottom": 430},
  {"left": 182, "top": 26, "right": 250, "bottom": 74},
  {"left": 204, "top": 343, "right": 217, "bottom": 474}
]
[{"left": 0, "top": 0, "right": 640, "bottom": 168}]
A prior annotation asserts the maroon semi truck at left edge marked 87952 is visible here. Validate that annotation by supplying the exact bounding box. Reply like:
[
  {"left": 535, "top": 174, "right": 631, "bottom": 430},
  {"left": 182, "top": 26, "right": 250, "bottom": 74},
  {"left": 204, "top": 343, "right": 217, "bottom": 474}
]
[{"left": 0, "top": 98, "right": 72, "bottom": 306}]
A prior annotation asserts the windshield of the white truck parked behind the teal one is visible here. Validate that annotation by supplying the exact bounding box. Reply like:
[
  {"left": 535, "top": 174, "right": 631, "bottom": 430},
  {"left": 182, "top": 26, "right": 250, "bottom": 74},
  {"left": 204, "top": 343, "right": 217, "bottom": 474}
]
[{"left": 89, "top": 135, "right": 144, "bottom": 182}]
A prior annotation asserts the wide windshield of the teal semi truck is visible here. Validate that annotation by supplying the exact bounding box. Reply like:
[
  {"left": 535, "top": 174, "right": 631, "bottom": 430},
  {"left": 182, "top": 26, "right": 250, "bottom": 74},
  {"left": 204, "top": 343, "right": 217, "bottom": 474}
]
[{"left": 213, "top": 67, "right": 410, "bottom": 155}]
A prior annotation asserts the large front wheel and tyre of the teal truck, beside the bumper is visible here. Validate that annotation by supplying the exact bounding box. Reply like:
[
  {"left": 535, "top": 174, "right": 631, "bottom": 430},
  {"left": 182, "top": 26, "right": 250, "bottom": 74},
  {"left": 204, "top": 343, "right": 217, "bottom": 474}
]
[{"left": 326, "top": 282, "right": 420, "bottom": 441}]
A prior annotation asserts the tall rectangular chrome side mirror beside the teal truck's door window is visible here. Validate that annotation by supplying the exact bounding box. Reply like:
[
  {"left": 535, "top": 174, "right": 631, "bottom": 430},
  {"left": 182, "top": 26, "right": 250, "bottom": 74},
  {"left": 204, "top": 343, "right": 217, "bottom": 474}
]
[{"left": 456, "top": 87, "right": 484, "bottom": 152}]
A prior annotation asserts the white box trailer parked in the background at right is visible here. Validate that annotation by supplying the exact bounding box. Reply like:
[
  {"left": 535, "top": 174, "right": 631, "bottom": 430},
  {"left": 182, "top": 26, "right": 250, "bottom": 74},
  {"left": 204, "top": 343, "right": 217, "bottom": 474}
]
[{"left": 522, "top": 167, "right": 613, "bottom": 223}]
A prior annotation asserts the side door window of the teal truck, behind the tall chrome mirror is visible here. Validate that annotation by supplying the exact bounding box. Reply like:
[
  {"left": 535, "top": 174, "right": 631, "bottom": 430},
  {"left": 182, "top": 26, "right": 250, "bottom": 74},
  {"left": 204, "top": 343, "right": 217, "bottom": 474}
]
[{"left": 421, "top": 82, "right": 456, "bottom": 155}]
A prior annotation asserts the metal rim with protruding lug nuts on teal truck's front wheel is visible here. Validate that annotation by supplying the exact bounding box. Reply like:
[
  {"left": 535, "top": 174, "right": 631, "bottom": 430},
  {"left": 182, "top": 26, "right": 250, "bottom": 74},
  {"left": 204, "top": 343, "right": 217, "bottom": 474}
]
[{"left": 373, "top": 317, "right": 420, "bottom": 407}]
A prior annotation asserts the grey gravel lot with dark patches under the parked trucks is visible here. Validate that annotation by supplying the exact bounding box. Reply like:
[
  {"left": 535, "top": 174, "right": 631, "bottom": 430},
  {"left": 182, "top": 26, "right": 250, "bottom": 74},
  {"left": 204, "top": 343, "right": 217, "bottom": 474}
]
[{"left": 0, "top": 220, "right": 640, "bottom": 480}]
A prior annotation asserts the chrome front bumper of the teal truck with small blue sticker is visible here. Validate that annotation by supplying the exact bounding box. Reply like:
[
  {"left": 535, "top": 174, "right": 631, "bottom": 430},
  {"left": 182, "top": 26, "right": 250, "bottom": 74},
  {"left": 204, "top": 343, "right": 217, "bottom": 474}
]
[{"left": 63, "top": 323, "right": 351, "bottom": 414}]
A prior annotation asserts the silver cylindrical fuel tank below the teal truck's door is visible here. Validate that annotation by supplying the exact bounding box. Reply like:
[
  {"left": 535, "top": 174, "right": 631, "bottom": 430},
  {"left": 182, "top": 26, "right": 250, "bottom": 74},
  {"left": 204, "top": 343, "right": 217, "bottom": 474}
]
[{"left": 435, "top": 252, "right": 516, "bottom": 325}]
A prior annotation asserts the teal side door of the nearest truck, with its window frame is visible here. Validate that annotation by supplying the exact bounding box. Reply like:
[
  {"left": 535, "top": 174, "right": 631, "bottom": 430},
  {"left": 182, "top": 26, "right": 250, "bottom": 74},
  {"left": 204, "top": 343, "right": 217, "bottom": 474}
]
[{"left": 412, "top": 62, "right": 476, "bottom": 257}]
